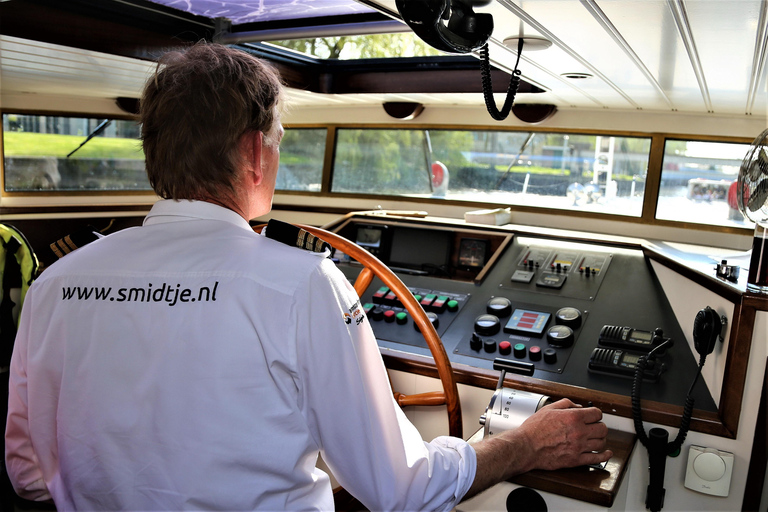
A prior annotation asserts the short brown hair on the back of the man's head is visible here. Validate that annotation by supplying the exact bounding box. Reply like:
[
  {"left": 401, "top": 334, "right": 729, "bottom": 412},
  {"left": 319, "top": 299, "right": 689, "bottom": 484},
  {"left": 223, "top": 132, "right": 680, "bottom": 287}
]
[{"left": 140, "top": 43, "right": 282, "bottom": 199}]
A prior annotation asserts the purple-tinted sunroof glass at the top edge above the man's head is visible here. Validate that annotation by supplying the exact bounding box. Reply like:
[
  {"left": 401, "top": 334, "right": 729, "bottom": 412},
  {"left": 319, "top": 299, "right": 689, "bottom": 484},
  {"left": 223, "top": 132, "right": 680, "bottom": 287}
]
[{"left": 146, "top": 0, "right": 375, "bottom": 25}]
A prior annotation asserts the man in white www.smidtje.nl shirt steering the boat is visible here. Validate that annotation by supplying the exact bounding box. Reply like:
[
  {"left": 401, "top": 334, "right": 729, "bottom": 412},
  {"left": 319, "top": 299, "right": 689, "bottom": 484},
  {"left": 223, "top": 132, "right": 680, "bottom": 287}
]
[{"left": 6, "top": 44, "right": 611, "bottom": 510}]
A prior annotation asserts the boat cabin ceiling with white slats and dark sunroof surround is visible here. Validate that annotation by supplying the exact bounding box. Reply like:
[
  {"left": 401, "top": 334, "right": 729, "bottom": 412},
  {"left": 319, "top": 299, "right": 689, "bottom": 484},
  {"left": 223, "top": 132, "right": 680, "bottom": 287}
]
[{"left": 0, "top": 0, "right": 768, "bottom": 117}]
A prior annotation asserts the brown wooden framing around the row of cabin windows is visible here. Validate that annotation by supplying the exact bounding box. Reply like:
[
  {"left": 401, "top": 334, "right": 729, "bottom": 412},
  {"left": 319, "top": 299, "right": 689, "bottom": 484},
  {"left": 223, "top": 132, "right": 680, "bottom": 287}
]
[{"left": 0, "top": 109, "right": 753, "bottom": 235}]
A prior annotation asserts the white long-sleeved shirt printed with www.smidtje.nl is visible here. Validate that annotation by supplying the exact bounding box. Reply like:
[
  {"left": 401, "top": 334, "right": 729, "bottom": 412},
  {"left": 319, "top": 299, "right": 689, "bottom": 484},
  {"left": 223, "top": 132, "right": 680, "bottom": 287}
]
[{"left": 6, "top": 201, "right": 476, "bottom": 510}]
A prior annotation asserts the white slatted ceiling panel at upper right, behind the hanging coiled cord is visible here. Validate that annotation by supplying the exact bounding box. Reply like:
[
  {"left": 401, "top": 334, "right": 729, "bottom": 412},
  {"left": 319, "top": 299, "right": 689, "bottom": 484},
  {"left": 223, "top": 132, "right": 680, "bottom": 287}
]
[{"left": 368, "top": 0, "right": 768, "bottom": 115}]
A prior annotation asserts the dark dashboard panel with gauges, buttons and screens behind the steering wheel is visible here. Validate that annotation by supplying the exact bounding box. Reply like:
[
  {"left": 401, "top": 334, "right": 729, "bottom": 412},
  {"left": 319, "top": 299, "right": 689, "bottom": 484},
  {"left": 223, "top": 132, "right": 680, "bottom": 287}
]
[{"left": 337, "top": 215, "right": 717, "bottom": 412}]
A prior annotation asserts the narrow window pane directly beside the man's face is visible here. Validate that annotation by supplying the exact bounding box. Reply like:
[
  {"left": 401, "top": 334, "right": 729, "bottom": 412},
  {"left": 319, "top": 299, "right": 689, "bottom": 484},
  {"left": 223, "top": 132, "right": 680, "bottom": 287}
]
[{"left": 275, "top": 128, "right": 328, "bottom": 192}]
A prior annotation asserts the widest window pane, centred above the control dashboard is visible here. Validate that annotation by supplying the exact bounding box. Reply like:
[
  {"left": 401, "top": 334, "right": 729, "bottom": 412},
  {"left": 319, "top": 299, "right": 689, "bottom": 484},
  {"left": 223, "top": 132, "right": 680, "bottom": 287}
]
[{"left": 331, "top": 129, "right": 651, "bottom": 217}]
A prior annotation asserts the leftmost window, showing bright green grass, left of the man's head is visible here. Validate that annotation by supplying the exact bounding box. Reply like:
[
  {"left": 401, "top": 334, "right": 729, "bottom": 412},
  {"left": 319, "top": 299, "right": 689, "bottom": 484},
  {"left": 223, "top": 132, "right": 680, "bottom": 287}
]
[{"left": 3, "top": 114, "right": 151, "bottom": 192}]
